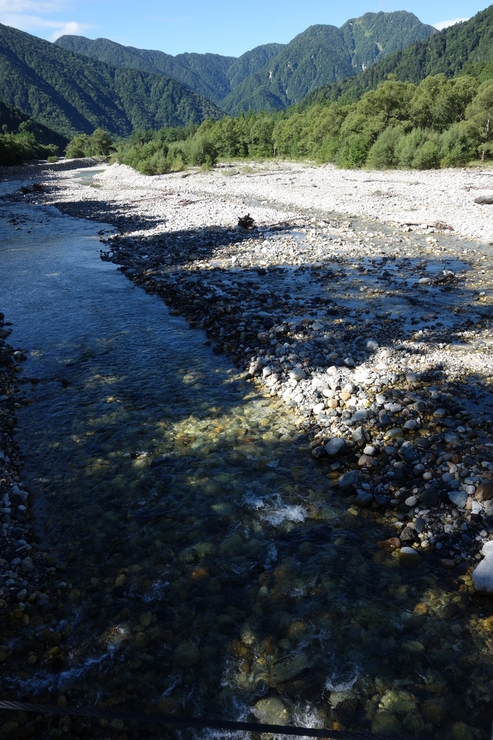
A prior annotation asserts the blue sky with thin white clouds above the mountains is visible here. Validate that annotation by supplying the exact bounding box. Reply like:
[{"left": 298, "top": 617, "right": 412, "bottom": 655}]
[{"left": 0, "top": 0, "right": 487, "bottom": 56}]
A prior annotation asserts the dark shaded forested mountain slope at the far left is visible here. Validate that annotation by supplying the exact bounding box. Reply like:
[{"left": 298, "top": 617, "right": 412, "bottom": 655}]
[{"left": 0, "top": 24, "right": 222, "bottom": 138}]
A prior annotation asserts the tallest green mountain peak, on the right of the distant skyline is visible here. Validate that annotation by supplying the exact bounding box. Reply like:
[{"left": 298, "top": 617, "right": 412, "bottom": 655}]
[{"left": 220, "top": 10, "right": 437, "bottom": 115}]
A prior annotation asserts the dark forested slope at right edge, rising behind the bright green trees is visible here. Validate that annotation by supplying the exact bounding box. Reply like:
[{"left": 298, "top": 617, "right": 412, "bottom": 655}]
[{"left": 302, "top": 5, "right": 493, "bottom": 107}]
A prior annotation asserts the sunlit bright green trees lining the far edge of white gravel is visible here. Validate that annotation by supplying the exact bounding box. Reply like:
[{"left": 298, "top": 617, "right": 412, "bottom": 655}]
[{"left": 100, "top": 74, "right": 493, "bottom": 175}]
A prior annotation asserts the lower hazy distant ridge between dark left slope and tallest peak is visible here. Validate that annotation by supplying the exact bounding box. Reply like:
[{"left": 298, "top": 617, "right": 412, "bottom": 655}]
[{"left": 55, "top": 35, "right": 282, "bottom": 105}]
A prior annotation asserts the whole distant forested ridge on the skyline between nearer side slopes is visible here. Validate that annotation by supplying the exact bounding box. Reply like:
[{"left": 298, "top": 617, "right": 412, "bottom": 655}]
[{"left": 56, "top": 11, "right": 436, "bottom": 115}]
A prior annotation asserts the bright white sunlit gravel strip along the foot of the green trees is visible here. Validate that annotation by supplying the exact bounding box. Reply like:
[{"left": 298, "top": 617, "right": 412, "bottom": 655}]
[{"left": 94, "top": 162, "right": 493, "bottom": 242}]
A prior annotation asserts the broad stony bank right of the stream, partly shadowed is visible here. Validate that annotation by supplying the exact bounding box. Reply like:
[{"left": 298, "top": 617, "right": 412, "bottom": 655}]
[{"left": 5, "top": 158, "right": 493, "bottom": 592}]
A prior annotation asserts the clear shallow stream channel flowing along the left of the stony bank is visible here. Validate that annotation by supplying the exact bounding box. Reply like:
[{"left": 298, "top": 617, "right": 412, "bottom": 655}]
[{"left": 0, "top": 181, "right": 492, "bottom": 740}]
